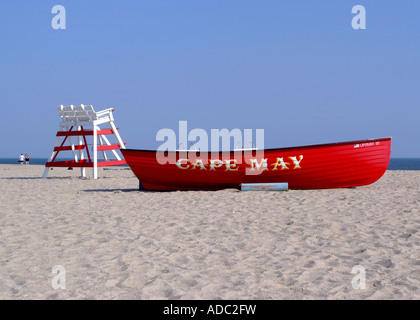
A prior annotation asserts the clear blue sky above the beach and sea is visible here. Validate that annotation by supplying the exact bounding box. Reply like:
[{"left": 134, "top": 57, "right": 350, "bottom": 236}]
[{"left": 0, "top": 0, "right": 420, "bottom": 158}]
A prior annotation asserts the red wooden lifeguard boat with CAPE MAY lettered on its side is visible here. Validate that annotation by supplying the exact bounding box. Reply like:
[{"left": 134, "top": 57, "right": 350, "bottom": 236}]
[{"left": 121, "top": 138, "right": 391, "bottom": 190}]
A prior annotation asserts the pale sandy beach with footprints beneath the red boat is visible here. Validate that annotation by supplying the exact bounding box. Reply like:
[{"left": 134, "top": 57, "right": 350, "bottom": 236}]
[{"left": 0, "top": 165, "right": 420, "bottom": 300}]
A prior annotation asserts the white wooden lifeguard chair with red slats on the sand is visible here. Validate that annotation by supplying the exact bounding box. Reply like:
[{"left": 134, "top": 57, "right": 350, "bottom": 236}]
[{"left": 42, "top": 104, "right": 127, "bottom": 179}]
